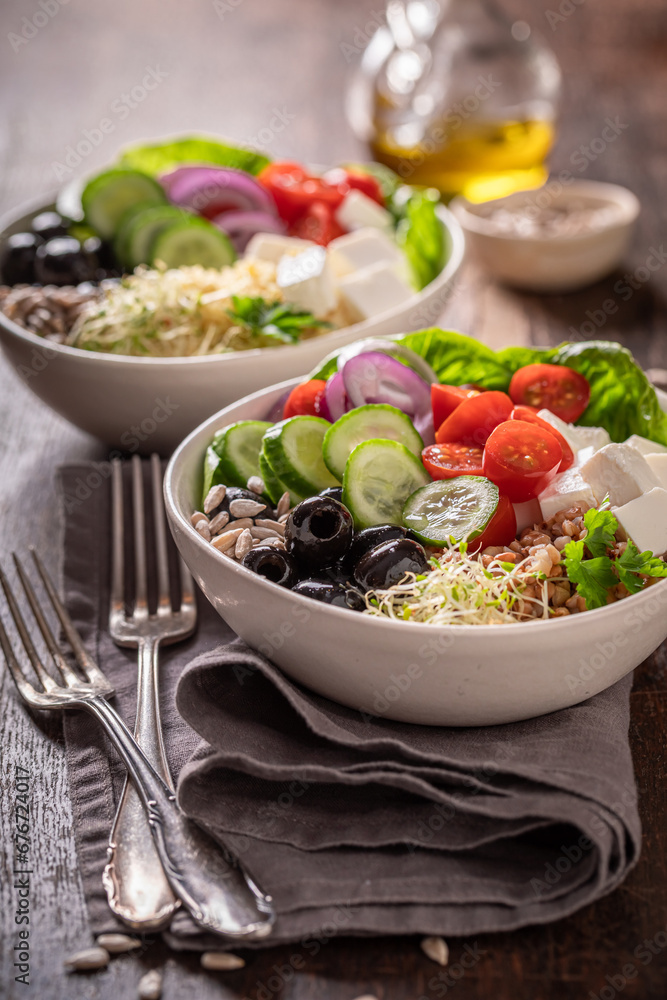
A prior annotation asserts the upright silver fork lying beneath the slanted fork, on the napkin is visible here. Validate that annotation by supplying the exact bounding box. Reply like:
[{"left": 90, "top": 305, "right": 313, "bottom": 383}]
[{"left": 103, "top": 455, "right": 197, "bottom": 932}]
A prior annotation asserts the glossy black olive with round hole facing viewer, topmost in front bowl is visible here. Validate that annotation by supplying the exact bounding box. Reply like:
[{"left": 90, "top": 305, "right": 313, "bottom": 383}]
[{"left": 285, "top": 497, "right": 353, "bottom": 567}]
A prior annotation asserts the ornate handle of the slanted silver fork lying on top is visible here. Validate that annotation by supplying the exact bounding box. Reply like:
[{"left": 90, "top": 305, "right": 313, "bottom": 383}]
[{"left": 87, "top": 695, "right": 275, "bottom": 938}]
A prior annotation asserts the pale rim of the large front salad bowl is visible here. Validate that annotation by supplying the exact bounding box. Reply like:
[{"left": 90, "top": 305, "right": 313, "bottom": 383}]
[{"left": 164, "top": 379, "right": 667, "bottom": 638}]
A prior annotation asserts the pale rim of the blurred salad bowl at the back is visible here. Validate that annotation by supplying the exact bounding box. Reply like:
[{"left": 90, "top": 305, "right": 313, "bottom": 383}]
[{"left": 0, "top": 196, "right": 465, "bottom": 368}]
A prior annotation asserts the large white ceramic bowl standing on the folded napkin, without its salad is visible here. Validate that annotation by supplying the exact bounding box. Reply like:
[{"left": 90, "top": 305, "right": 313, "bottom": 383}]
[{"left": 165, "top": 382, "right": 667, "bottom": 726}]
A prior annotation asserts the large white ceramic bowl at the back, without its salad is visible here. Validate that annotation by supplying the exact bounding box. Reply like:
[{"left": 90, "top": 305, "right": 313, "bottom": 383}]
[{"left": 0, "top": 196, "right": 465, "bottom": 455}]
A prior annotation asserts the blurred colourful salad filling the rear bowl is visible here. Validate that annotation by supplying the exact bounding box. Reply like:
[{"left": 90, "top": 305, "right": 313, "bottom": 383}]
[{"left": 0, "top": 137, "right": 448, "bottom": 357}]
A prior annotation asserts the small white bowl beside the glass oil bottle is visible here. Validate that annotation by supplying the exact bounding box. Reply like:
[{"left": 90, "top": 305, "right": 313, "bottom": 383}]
[{"left": 451, "top": 180, "right": 640, "bottom": 292}]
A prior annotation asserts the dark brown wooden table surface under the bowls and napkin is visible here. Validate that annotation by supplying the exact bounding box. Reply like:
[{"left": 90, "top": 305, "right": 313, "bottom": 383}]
[{"left": 0, "top": 0, "right": 667, "bottom": 1000}]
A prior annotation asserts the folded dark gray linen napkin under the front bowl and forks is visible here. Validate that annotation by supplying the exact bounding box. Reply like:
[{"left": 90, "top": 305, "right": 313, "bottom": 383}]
[{"left": 60, "top": 465, "right": 641, "bottom": 947}]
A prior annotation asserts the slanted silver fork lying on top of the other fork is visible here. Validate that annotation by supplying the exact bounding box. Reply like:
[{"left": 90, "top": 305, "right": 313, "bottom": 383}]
[{"left": 0, "top": 551, "right": 275, "bottom": 938}]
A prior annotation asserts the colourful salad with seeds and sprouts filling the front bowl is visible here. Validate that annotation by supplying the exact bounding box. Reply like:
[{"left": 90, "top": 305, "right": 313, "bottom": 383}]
[{"left": 192, "top": 329, "right": 667, "bottom": 625}]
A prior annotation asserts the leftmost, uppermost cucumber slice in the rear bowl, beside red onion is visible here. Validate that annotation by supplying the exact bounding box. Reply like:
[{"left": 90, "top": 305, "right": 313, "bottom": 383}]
[{"left": 81, "top": 169, "right": 167, "bottom": 240}]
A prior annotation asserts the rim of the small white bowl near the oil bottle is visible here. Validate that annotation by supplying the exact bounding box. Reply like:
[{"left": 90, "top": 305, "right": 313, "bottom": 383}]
[{"left": 450, "top": 179, "right": 641, "bottom": 246}]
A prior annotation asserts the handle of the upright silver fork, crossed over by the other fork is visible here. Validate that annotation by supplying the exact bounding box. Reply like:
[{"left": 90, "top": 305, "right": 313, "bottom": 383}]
[{"left": 103, "top": 638, "right": 179, "bottom": 933}]
